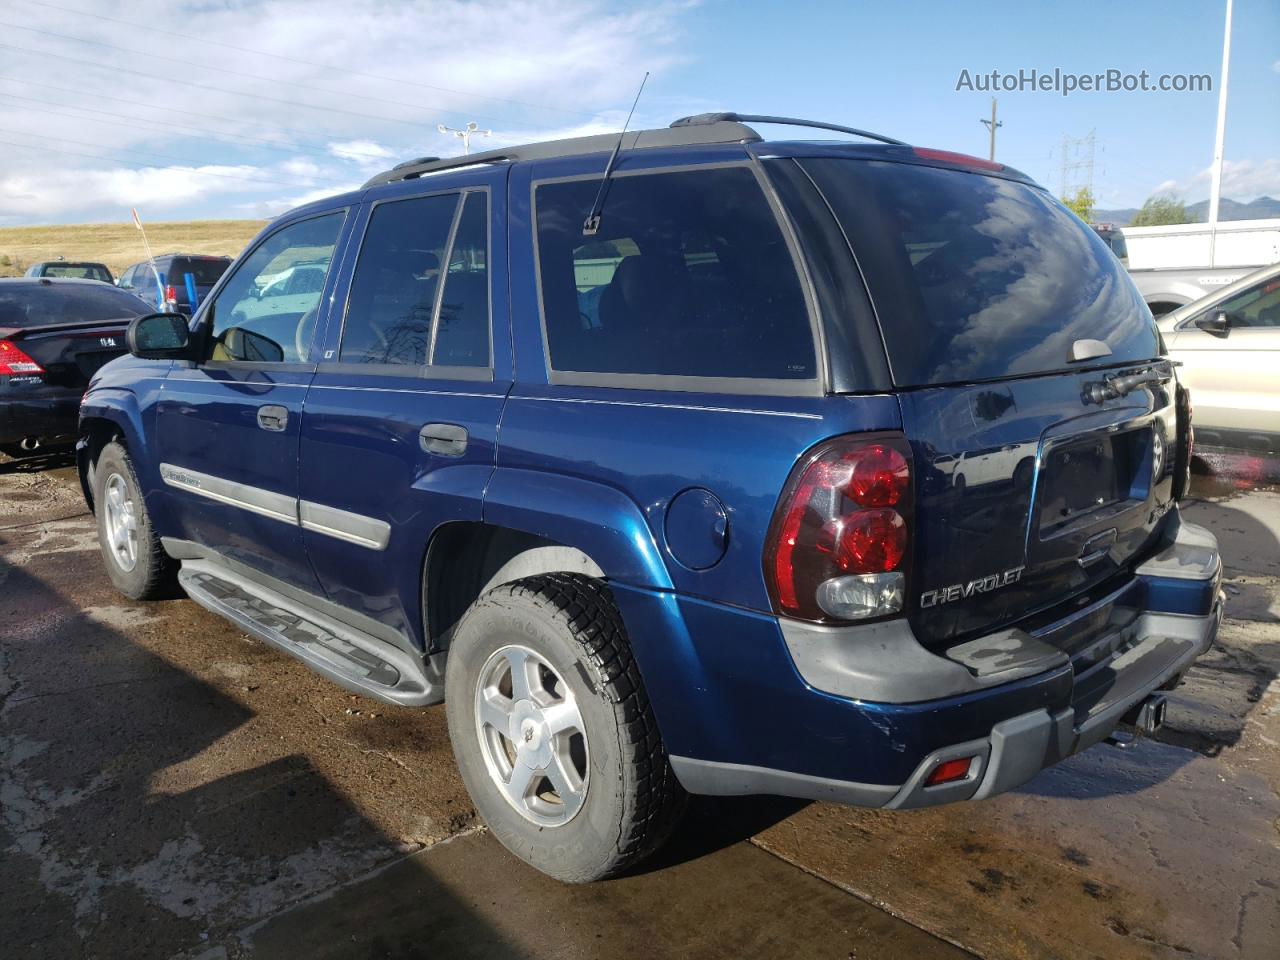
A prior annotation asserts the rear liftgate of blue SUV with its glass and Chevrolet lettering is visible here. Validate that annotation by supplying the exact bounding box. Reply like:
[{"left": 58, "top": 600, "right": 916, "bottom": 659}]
[{"left": 799, "top": 159, "right": 1175, "bottom": 644}]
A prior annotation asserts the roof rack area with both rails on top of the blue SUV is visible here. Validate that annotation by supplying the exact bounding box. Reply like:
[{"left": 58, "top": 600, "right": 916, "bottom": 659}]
[{"left": 365, "top": 113, "right": 902, "bottom": 189}]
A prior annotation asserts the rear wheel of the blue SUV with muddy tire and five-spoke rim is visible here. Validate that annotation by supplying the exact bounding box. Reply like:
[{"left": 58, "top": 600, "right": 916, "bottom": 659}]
[{"left": 445, "top": 573, "right": 685, "bottom": 883}]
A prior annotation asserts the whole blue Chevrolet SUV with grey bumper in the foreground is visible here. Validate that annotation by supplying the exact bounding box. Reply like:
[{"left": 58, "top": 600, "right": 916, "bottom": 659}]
[{"left": 79, "top": 114, "right": 1222, "bottom": 881}]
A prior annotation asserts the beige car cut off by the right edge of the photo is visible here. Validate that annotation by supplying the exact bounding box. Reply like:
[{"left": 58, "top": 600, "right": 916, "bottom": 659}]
[{"left": 1160, "top": 264, "right": 1280, "bottom": 454}]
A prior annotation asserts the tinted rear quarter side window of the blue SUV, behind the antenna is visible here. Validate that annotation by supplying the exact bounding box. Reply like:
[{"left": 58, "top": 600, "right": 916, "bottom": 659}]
[{"left": 536, "top": 166, "right": 817, "bottom": 380}]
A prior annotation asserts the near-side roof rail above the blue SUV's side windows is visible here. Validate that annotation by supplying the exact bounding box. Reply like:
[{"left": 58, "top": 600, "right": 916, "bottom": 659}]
[{"left": 365, "top": 120, "right": 760, "bottom": 189}]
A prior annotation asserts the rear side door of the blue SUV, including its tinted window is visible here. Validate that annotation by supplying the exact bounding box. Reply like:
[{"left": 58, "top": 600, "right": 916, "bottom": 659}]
[{"left": 299, "top": 168, "right": 511, "bottom": 647}]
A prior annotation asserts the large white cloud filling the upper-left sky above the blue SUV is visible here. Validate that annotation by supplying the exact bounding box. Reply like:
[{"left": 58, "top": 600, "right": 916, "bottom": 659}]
[{"left": 0, "top": 0, "right": 690, "bottom": 223}]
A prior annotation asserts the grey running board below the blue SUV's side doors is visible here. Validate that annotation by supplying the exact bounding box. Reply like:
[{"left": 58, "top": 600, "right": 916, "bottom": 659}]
[{"left": 178, "top": 559, "right": 444, "bottom": 707}]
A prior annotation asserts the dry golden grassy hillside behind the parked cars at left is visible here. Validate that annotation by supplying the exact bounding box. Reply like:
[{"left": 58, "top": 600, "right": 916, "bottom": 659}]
[{"left": 0, "top": 220, "right": 266, "bottom": 276}]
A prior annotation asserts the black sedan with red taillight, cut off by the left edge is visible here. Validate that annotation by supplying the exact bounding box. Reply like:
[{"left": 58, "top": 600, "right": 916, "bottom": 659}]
[{"left": 0, "top": 278, "right": 151, "bottom": 457}]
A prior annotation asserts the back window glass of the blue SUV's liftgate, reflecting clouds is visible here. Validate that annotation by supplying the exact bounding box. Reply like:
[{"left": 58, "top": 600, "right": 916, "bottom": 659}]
[{"left": 800, "top": 159, "right": 1160, "bottom": 387}]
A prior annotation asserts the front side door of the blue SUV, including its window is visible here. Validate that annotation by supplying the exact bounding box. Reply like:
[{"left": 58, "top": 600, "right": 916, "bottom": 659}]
[{"left": 156, "top": 210, "right": 346, "bottom": 590}]
